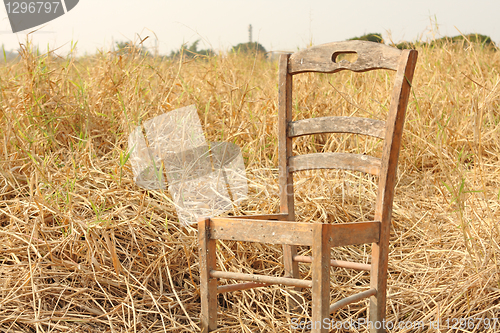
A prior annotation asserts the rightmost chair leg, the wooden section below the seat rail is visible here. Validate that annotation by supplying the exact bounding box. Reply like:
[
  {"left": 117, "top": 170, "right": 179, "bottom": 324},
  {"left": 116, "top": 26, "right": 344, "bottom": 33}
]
[{"left": 369, "top": 242, "right": 389, "bottom": 333}]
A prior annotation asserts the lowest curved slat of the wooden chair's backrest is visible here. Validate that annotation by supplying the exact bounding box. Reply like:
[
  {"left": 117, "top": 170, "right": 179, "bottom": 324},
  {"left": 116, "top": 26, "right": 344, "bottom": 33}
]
[{"left": 289, "top": 153, "right": 382, "bottom": 176}]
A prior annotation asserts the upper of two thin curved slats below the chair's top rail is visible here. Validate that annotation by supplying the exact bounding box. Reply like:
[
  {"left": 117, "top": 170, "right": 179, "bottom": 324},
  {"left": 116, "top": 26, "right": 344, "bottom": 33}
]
[{"left": 288, "top": 117, "right": 385, "bottom": 139}]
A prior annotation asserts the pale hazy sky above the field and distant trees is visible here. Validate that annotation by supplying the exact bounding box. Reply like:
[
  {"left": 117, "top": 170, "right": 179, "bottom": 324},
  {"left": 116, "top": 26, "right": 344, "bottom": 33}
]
[{"left": 0, "top": 0, "right": 500, "bottom": 55}]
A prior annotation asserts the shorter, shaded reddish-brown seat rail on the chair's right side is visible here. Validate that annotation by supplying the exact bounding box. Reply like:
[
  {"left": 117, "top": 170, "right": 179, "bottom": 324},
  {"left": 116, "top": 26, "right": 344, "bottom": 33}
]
[{"left": 328, "top": 221, "right": 380, "bottom": 247}]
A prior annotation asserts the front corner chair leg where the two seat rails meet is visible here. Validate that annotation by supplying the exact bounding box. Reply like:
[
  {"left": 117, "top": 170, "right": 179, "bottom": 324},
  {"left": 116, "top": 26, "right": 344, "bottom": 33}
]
[{"left": 311, "top": 224, "right": 330, "bottom": 333}]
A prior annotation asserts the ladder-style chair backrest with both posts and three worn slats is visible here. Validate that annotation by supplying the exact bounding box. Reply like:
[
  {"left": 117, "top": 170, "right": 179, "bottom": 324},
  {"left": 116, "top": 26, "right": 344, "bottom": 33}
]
[{"left": 278, "top": 41, "right": 417, "bottom": 228}]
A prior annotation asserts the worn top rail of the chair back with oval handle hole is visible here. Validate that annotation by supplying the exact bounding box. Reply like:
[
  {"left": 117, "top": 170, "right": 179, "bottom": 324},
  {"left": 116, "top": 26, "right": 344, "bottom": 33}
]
[{"left": 288, "top": 41, "right": 401, "bottom": 74}]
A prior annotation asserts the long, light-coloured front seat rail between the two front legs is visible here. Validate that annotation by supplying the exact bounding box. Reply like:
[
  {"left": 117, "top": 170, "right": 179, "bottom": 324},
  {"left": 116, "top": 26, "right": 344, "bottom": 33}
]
[{"left": 210, "top": 217, "right": 313, "bottom": 246}]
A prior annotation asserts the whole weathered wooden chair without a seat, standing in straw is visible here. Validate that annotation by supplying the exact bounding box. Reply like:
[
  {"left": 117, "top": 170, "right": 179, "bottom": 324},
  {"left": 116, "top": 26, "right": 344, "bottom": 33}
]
[{"left": 198, "top": 41, "right": 417, "bottom": 332}]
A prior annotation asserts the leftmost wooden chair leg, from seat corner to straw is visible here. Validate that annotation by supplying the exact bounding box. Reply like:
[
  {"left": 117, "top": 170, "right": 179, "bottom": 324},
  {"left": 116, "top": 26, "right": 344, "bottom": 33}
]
[{"left": 198, "top": 218, "right": 217, "bottom": 333}]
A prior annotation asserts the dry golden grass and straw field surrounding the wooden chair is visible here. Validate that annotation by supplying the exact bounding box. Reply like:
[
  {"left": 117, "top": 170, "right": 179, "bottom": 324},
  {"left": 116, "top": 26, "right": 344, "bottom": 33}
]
[{"left": 0, "top": 39, "right": 500, "bottom": 333}]
